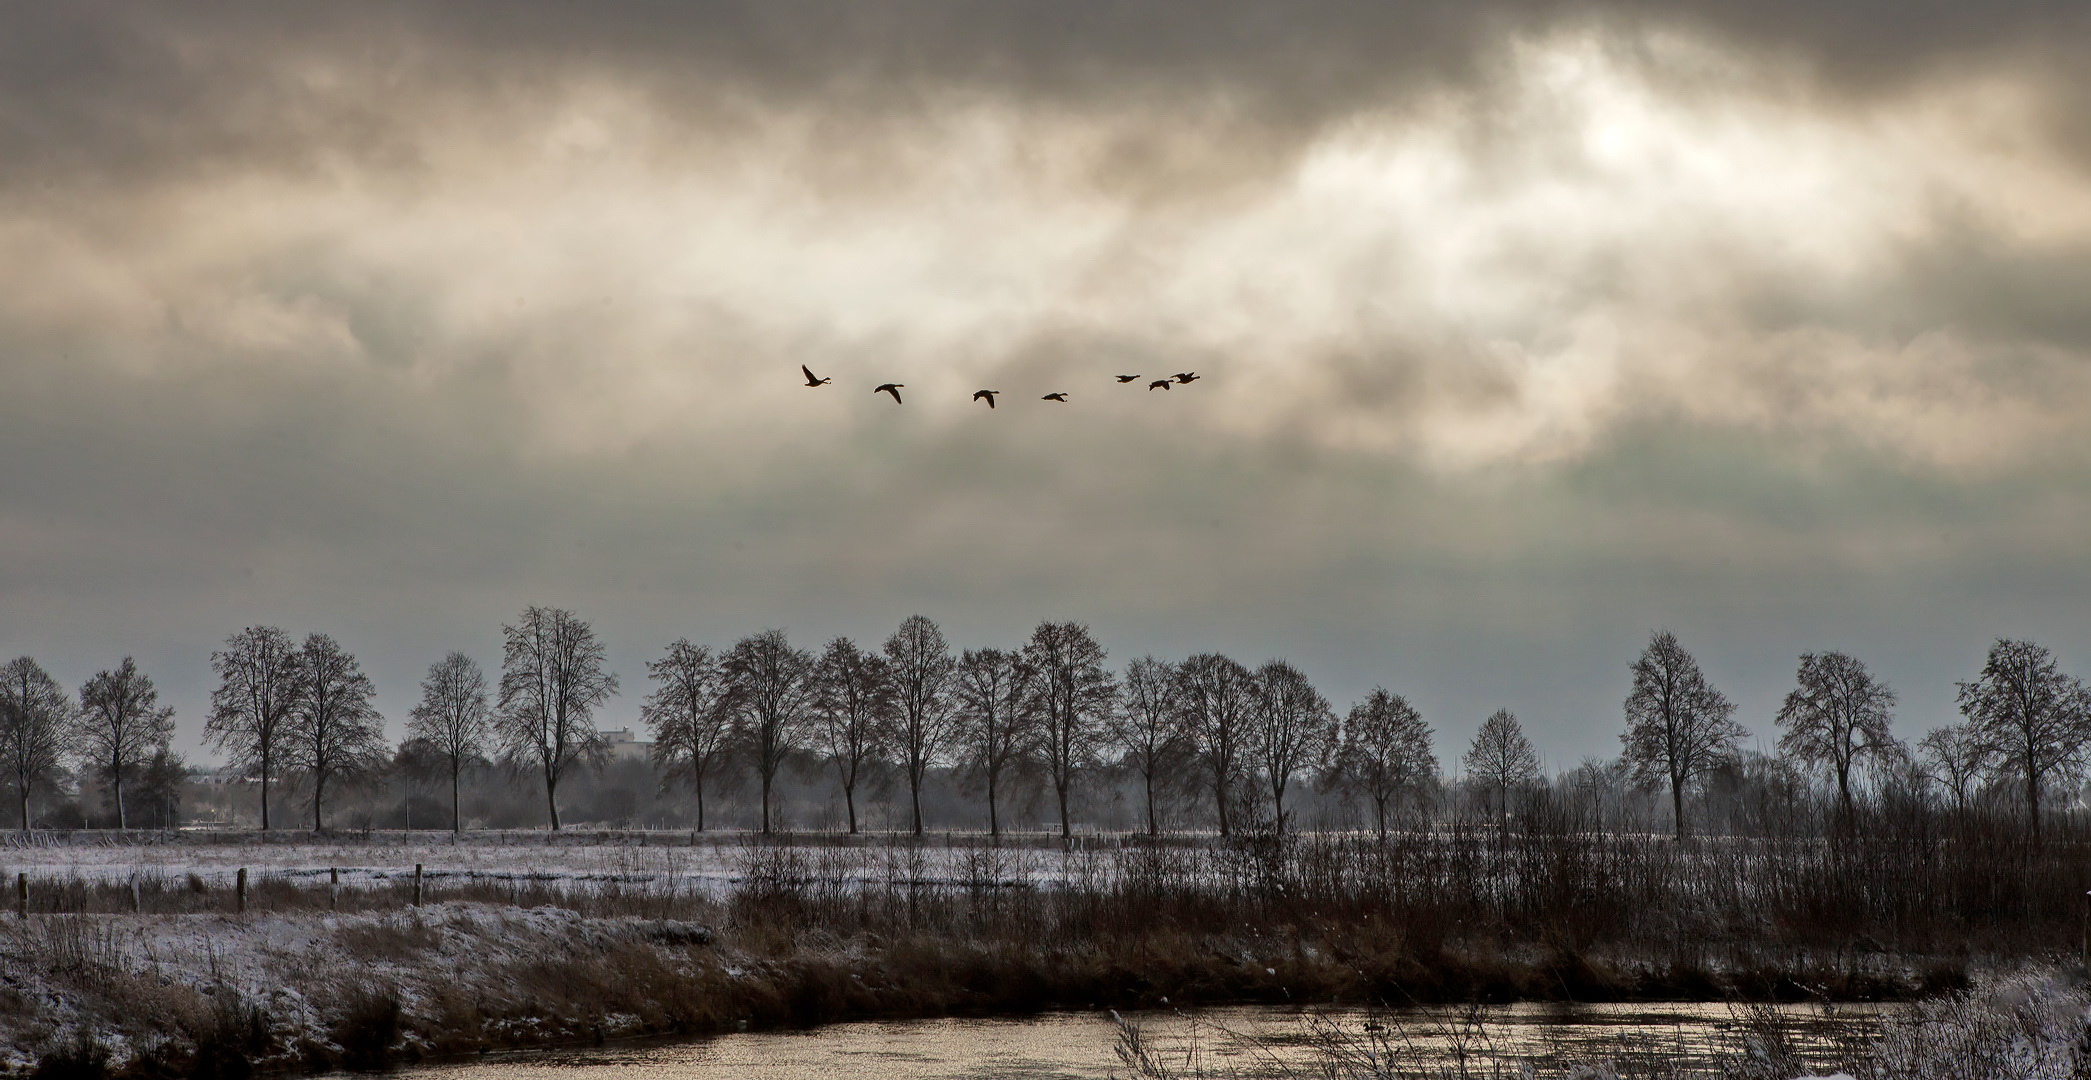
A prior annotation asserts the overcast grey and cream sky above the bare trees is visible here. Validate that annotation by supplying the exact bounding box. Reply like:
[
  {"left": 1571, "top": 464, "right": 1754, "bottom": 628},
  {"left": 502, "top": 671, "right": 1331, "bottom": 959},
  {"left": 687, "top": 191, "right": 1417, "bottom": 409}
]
[{"left": 0, "top": 0, "right": 2091, "bottom": 768}]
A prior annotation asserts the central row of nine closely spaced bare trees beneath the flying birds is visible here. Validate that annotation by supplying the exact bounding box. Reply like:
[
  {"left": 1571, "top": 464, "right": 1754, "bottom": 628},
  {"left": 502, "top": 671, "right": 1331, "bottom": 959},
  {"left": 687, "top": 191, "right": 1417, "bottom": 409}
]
[{"left": 642, "top": 615, "right": 1329, "bottom": 835}]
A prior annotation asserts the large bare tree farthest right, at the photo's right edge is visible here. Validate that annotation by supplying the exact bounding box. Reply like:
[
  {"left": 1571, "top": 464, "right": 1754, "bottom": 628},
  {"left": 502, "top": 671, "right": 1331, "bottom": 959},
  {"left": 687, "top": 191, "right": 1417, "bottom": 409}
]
[{"left": 1959, "top": 638, "right": 2091, "bottom": 839}]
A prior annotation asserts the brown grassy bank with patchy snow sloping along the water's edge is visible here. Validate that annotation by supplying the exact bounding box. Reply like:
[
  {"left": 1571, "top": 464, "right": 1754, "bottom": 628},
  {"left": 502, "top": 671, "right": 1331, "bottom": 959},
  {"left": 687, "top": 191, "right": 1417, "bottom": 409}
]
[{"left": 0, "top": 902, "right": 1961, "bottom": 1076}]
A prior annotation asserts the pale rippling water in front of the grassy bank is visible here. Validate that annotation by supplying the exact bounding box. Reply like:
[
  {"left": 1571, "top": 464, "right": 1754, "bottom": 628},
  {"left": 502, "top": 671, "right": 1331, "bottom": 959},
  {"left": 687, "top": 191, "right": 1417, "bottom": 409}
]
[{"left": 414, "top": 1005, "right": 1876, "bottom": 1080}]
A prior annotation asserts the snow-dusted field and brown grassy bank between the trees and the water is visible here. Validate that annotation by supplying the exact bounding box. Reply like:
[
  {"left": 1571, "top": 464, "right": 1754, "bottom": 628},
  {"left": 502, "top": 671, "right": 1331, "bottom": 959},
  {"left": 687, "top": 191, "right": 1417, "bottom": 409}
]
[{"left": 0, "top": 835, "right": 2076, "bottom": 1076}]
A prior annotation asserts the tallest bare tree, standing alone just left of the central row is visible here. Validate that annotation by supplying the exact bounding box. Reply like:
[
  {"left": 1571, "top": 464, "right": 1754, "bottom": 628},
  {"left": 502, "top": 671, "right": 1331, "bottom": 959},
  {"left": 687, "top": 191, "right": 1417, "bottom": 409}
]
[{"left": 496, "top": 605, "right": 617, "bottom": 831}]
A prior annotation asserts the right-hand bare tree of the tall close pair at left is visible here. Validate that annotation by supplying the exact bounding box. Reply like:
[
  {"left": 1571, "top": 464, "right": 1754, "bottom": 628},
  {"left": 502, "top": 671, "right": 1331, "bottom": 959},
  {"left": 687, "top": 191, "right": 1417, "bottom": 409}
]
[{"left": 284, "top": 634, "right": 385, "bottom": 833}]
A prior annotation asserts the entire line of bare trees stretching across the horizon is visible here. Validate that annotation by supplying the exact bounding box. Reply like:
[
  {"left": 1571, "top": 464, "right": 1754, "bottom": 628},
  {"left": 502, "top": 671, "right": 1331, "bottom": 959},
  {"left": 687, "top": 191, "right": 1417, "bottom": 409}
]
[{"left": 0, "top": 607, "right": 2091, "bottom": 839}]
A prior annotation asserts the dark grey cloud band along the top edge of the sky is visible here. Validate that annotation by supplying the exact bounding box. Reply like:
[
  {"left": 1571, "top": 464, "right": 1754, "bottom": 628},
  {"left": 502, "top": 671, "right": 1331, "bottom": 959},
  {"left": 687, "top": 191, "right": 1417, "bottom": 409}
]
[{"left": 12, "top": 0, "right": 2091, "bottom": 182}]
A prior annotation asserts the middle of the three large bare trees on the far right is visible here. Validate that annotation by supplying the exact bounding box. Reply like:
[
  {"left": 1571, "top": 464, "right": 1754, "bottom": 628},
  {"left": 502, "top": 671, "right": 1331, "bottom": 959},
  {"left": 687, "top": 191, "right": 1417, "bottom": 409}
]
[{"left": 1777, "top": 653, "right": 1903, "bottom": 820}]
